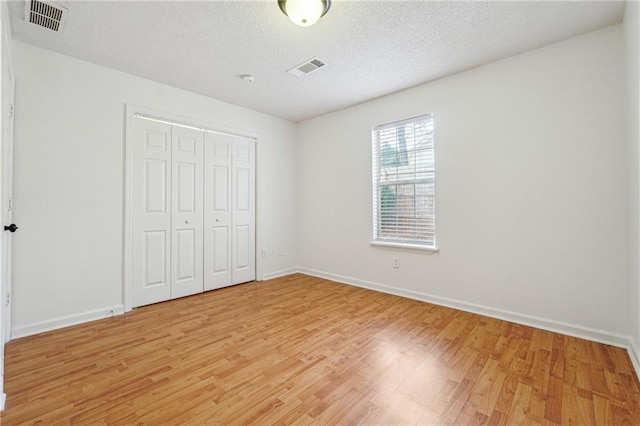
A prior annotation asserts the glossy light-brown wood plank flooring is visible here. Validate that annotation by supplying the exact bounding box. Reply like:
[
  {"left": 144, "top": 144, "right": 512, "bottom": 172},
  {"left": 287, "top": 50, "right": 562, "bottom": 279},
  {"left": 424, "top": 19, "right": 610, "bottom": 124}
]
[{"left": 1, "top": 274, "right": 640, "bottom": 425}]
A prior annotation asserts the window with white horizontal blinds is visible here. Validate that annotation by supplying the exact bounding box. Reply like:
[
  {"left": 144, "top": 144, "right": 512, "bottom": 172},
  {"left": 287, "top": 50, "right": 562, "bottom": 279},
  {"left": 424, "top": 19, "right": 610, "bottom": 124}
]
[{"left": 372, "top": 114, "right": 437, "bottom": 251}]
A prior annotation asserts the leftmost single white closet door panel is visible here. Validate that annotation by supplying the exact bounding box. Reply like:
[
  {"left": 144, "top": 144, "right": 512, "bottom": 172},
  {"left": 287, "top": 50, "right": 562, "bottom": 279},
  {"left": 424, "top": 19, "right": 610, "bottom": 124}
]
[{"left": 131, "top": 120, "right": 171, "bottom": 306}]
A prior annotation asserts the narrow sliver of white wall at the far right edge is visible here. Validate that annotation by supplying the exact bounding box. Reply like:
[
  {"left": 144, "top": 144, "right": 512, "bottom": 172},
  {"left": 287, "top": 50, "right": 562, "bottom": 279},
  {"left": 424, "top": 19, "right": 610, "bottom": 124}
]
[{"left": 623, "top": 1, "right": 640, "bottom": 364}]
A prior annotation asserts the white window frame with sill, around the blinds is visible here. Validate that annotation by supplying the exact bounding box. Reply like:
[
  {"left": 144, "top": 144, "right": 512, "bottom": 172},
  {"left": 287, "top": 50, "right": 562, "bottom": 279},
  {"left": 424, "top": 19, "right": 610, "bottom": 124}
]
[{"left": 370, "top": 113, "right": 439, "bottom": 253}]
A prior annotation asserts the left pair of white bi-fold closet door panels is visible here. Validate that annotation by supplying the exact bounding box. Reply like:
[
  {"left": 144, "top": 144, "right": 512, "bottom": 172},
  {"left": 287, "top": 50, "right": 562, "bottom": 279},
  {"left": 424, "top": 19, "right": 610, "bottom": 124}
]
[{"left": 131, "top": 120, "right": 204, "bottom": 306}]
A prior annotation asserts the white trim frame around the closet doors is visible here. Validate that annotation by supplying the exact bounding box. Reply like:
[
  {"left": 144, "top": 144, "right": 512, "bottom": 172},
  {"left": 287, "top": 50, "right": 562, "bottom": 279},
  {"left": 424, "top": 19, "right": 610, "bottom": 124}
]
[{"left": 122, "top": 104, "right": 263, "bottom": 312}]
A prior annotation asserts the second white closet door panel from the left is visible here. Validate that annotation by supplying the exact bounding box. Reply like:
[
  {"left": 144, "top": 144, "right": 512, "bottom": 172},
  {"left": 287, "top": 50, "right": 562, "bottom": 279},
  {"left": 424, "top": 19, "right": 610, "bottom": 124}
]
[{"left": 171, "top": 126, "right": 204, "bottom": 299}]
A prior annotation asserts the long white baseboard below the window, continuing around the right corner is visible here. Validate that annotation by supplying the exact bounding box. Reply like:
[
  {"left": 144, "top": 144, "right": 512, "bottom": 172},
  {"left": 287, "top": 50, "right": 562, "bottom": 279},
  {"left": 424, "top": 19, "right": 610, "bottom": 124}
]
[{"left": 298, "top": 268, "right": 640, "bottom": 378}]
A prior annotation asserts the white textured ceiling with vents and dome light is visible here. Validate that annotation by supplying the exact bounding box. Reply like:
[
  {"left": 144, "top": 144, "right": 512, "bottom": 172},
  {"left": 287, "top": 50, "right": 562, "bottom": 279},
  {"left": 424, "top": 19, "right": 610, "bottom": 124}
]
[{"left": 9, "top": 0, "right": 624, "bottom": 122}]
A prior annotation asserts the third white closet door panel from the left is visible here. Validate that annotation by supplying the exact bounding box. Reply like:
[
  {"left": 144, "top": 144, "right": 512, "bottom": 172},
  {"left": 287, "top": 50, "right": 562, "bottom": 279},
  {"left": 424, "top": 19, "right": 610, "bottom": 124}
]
[{"left": 204, "top": 133, "right": 233, "bottom": 290}]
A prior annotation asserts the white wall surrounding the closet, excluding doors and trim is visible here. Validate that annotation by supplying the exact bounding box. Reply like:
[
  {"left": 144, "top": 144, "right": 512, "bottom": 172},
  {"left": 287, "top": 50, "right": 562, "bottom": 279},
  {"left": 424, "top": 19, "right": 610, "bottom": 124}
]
[{"left": 12, "top": 43, "right": 298, "bottom": 337}]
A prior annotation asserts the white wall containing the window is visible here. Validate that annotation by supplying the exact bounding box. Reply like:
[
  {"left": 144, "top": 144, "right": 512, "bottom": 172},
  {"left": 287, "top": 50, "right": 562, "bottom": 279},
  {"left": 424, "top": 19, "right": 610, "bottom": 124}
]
[{"left": 298, "top": 25, "right": 631, "bottom": 336}]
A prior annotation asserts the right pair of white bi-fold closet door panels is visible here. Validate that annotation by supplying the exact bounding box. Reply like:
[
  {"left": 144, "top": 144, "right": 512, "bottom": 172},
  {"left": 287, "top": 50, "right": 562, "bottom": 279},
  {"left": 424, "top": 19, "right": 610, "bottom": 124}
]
[{"left": 204, "top": 133, "right": 256, "bottom": 290}]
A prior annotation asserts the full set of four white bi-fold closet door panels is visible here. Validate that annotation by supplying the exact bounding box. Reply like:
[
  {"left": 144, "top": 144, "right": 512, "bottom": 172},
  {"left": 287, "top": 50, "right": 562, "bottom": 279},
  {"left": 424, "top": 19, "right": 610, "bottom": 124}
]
[{"left": 130, "top": 112, "right": 256, "bottom": 307}]
